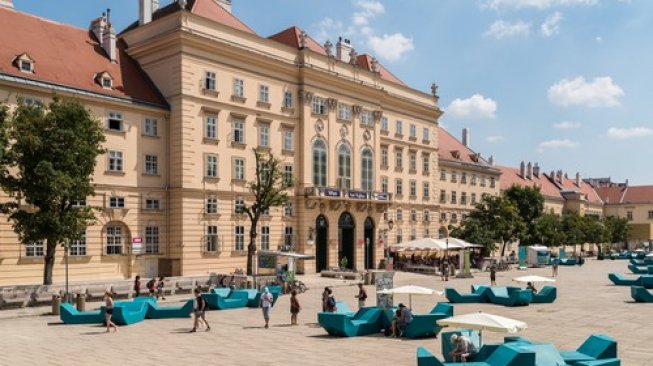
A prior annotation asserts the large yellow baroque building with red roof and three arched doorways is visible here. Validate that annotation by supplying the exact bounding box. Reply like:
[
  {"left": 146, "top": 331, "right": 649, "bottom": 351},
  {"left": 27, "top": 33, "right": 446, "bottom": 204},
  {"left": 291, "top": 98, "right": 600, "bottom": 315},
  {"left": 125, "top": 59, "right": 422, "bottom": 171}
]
[{"left": 0, "top": 0, "right": 442, "bottom": 285}]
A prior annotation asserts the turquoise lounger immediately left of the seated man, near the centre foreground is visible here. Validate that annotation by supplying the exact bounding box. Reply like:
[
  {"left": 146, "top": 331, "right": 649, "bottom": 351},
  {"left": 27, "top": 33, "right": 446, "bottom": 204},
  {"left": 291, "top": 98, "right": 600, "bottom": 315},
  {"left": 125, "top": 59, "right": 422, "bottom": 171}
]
[{"left": 317, "top": 307, "right": 383, "bottom": 337}]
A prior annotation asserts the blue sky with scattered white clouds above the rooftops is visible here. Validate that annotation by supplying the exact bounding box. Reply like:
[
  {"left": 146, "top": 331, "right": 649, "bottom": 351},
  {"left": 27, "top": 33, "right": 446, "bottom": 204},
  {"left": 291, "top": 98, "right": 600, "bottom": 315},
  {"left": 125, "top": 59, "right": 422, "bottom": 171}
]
[{"left": 14, "top": 0, "right": 653, "bottom": 184}]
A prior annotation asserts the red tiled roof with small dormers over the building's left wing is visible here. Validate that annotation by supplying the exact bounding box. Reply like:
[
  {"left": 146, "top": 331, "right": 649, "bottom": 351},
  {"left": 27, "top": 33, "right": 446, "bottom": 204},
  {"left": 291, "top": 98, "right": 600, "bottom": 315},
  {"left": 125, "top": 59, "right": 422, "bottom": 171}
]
[{"left": 0, "top": 7, "right": 167, "bottom": 106}]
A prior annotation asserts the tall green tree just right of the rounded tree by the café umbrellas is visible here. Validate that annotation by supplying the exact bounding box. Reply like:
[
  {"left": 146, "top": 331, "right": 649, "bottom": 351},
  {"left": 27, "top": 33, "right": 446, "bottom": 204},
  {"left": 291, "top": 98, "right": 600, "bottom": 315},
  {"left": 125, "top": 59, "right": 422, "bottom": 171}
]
[{"left": 503, "top": 185, "right": 544, "bottom": 245}]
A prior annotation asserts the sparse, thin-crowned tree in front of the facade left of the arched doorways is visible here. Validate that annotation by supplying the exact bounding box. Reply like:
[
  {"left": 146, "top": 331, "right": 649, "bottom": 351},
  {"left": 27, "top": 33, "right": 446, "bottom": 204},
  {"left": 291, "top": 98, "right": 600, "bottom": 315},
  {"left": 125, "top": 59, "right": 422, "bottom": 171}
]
[{"left": 242, "top": 150, "right": 290, "bottom": 276}]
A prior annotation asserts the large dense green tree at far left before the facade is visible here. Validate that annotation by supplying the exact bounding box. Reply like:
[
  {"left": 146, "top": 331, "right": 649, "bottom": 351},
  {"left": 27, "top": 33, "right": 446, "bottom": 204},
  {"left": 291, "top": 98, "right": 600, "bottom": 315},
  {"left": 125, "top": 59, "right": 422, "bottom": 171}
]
[{"left": 0, "top": 99, "right": 104, "bottom": 285}]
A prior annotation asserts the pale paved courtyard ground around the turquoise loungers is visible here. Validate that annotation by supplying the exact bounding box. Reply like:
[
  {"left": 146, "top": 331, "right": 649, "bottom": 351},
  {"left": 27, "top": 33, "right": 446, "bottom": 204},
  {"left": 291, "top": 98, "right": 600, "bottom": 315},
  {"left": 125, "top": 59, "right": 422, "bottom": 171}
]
[{"left": 0, "top": 260, "right": 653, "bottom": 366}]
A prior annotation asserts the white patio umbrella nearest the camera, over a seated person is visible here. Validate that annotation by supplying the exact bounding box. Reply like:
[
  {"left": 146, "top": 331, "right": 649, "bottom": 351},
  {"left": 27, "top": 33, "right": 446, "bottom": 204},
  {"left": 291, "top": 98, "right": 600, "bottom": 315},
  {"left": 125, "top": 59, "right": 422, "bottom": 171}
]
[{"left": 437, "top": 312, "right": 528, "bottom": 344}]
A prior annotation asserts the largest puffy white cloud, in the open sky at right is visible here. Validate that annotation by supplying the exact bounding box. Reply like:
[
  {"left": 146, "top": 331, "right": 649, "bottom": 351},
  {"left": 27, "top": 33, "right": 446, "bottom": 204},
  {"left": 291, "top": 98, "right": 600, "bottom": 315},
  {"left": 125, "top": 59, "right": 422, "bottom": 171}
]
[{"left": 549, "top": 76, "right": 624, "bottom": 108}]
